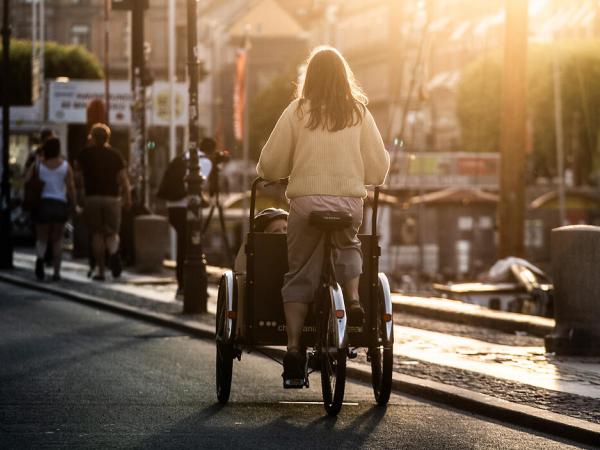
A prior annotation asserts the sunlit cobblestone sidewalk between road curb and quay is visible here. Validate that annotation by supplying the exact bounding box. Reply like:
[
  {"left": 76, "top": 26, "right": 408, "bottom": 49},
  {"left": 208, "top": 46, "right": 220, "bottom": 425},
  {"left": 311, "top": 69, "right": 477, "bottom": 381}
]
[{"left": 0, "top": 252, "right": 600, "bottom": 424}]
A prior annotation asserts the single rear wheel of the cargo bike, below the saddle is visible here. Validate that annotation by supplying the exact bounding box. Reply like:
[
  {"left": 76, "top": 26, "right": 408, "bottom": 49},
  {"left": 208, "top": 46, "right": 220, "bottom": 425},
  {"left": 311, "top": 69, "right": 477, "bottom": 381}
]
[{"left": 320, "top": 291, "right": 346, "bottom": 416}]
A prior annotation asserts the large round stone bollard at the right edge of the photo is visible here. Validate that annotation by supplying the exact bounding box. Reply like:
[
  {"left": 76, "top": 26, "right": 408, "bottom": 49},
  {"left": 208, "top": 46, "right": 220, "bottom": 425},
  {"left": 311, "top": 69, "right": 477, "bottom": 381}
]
[{"left": 545, "top": 225, "right": 600, "bottom": 356}]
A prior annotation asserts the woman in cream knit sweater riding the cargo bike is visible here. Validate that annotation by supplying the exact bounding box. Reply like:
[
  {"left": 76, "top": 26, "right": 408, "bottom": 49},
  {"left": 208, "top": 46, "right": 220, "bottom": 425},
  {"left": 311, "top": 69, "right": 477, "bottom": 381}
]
[{"left": 257, "top": 47, "right": 390, "bottom": 385}]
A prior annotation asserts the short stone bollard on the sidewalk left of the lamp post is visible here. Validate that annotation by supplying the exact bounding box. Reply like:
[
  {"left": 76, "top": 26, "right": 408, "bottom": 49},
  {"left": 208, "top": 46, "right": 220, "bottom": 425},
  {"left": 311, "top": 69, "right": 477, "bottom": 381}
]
[{"left": 133, "top": 215, "right": 169, "bottom": 273}]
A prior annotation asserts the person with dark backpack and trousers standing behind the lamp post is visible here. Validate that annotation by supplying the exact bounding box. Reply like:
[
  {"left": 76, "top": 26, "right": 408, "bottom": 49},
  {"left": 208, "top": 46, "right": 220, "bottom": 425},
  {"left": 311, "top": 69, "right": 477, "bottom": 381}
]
[{"left": 156, "top": 138, "right": 216, "bottom": 297}]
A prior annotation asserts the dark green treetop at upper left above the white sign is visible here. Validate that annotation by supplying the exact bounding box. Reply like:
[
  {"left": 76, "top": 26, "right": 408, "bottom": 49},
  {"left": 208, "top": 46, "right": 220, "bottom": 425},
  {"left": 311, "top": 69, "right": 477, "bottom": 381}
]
[{"left": 0, "top": 39, "right": 103, "bottom": 105}]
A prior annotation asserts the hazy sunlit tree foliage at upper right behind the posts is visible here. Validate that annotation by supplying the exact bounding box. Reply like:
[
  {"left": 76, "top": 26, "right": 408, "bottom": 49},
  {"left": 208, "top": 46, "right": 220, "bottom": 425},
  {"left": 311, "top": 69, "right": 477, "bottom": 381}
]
[{"left": 457, "top": 40, "right": 600, "bottom": 184}]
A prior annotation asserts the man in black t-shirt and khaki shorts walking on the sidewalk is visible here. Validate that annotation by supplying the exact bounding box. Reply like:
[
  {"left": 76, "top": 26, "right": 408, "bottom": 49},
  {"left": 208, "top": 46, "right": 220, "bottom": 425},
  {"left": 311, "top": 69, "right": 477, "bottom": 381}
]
[{"left": 76, "top": 123, "right": 131, "bottom": 281}]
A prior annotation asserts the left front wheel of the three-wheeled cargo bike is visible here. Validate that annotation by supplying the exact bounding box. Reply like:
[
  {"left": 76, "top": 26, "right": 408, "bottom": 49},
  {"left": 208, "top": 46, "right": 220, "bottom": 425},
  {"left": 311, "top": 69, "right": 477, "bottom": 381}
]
[{"left": 215, "top": 277, "right": 233, "bottom": 404}]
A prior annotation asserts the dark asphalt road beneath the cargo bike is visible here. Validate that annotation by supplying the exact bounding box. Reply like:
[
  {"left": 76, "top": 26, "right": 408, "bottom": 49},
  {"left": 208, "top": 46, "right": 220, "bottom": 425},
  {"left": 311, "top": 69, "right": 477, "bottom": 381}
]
[{"left": 0, "top": 283, "right": 592, "bottom": 449}]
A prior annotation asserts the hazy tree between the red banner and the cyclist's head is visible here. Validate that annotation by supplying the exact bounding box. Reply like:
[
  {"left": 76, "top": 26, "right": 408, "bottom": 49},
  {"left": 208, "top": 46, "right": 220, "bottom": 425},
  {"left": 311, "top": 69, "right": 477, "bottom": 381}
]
[{"left": 249, "top": 75, "right": 294, "bottom": 161}]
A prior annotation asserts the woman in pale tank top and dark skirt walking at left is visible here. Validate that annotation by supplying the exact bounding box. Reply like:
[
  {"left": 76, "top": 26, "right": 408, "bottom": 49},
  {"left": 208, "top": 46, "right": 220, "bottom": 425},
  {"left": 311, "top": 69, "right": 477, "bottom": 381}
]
[{"left": 26, "top": 137, "right": 75, "bottom": 281}]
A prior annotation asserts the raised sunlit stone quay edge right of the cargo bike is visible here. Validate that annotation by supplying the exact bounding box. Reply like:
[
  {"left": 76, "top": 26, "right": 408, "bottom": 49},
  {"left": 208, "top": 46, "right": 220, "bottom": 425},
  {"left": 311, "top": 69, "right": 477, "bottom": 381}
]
[{"left": 392, "top": 294, "right": 554, "bottom": 337}]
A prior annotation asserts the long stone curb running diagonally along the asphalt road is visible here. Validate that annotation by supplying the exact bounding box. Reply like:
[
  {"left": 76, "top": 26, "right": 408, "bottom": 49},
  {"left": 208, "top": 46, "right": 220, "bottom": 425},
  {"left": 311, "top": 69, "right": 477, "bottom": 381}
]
[{"left": 0, "top": 273, "right": 600, "bottom": 445}]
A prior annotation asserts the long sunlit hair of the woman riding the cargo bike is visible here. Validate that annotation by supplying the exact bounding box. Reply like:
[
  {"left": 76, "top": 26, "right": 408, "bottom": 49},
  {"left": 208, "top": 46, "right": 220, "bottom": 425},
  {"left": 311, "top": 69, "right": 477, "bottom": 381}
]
[{"left": 296, "top": 46, "right": 368, "bottom": 131}]
